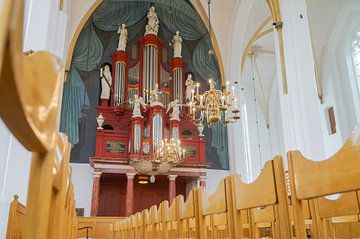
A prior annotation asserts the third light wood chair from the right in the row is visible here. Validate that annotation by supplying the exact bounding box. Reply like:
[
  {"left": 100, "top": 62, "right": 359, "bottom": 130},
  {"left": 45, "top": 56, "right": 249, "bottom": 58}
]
[{"left": 194, "top": 179, "right": 234, "bottom": 238}]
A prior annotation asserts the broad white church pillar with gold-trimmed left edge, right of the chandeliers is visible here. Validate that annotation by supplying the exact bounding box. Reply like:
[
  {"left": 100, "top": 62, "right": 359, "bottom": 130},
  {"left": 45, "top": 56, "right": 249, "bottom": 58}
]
[{"left": 270, "top": 0, "right": 326, "bottom": 163}]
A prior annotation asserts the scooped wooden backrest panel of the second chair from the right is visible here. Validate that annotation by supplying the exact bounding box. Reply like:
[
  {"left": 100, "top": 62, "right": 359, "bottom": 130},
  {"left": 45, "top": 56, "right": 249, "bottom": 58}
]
[{"left": 232, "top": 161, "right": 277, "bottom": 210}]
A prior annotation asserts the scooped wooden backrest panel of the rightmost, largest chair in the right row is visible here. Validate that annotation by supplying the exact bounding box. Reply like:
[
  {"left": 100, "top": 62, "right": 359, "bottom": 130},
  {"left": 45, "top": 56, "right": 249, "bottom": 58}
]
[{"left": 288, "top": 127, "right": 360, "bottom": 200}]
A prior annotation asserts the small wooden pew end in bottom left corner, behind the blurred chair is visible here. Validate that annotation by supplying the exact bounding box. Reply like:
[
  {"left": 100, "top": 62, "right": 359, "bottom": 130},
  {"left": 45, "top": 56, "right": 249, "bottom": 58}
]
[{"left": 6, "top": 195, "right": 26, "bottom": 239}]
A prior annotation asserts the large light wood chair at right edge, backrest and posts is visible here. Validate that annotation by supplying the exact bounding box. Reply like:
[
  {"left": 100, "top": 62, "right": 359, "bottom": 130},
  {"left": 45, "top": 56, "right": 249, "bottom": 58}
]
[{"left": 288, "top": 127, "right": 360, "bottom": 239}]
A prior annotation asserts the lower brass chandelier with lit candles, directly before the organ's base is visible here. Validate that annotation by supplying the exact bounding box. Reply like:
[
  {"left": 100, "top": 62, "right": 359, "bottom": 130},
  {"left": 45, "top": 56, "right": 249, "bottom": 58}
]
[{"left": 130, "top": 138, "right": 186, "bottom": 176}]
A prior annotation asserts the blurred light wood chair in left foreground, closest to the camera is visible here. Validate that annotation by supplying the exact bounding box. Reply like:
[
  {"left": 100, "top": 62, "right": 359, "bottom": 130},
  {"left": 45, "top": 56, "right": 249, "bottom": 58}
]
[{"left": 0, "top": 0, "right": 76, "bottom": 239}]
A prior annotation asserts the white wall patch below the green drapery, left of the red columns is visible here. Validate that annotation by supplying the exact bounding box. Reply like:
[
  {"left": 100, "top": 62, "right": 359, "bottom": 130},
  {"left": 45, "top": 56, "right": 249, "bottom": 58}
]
[{"left": 71, "top": 163, "right": 94, "bottom": 216}]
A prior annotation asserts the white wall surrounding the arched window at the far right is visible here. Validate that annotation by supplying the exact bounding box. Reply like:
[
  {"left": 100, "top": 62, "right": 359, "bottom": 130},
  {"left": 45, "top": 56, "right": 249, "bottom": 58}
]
[{"left": 307, "top": 0, "right": 360, "bottom": 157}]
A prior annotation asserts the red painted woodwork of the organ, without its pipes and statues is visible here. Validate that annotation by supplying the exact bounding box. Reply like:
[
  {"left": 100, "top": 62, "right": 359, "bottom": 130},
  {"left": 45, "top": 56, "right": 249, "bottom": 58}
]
[{"left": 90, "top": 30, "right": 207, "bottom": 216}]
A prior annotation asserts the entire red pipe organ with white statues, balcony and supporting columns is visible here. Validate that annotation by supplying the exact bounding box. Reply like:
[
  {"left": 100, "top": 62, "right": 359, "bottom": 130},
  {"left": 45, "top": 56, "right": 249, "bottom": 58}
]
[{"left": 90, "top": 7, "right": 208, "bottom": 216}]
